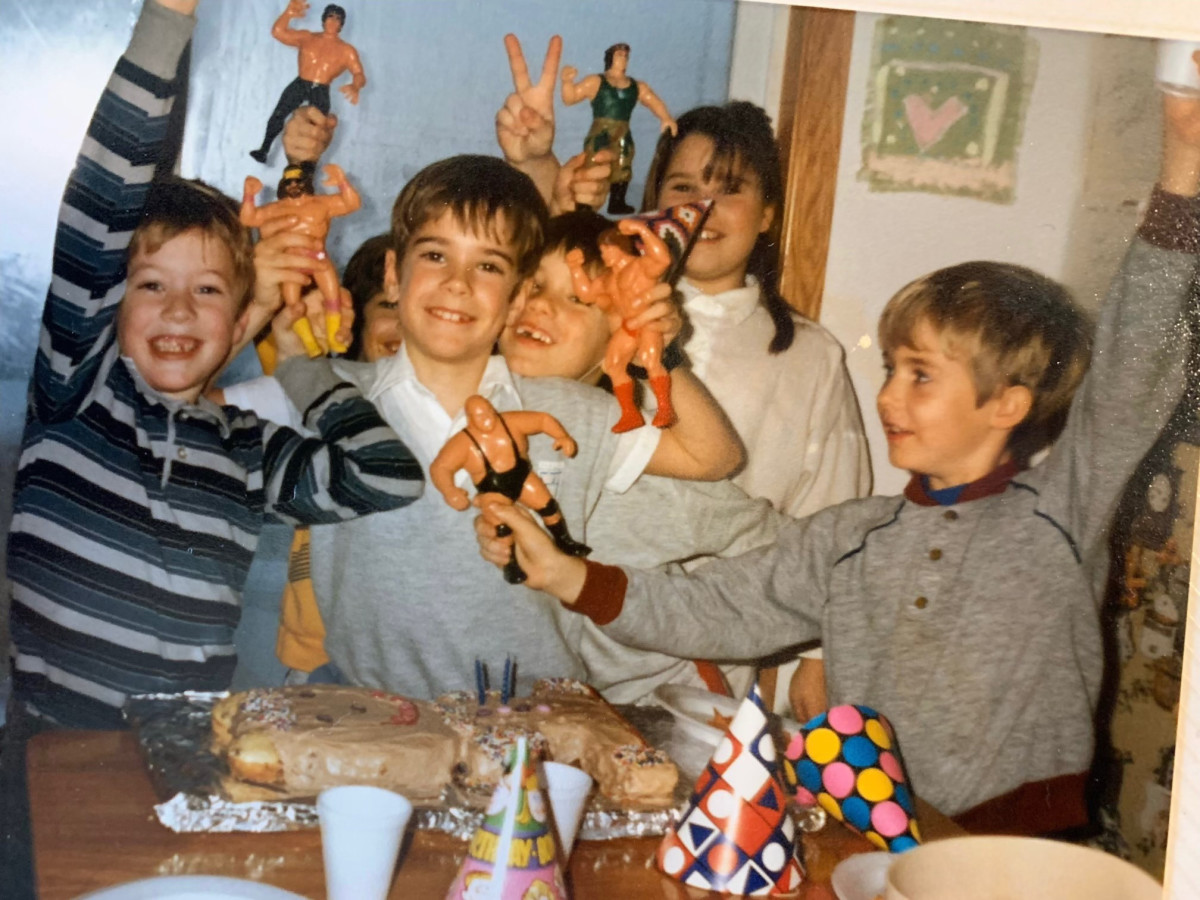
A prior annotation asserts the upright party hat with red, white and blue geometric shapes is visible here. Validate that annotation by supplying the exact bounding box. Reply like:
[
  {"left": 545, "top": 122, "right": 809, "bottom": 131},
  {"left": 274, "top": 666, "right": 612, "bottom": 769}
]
[{"left": 656, "top": 684, "right": 804, "bottom": 896}]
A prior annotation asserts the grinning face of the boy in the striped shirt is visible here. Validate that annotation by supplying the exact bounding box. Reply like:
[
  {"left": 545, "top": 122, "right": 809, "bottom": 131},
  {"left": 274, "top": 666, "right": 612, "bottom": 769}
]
[{"left": 116, "top": 229, "right": 245, "bottom": 403}]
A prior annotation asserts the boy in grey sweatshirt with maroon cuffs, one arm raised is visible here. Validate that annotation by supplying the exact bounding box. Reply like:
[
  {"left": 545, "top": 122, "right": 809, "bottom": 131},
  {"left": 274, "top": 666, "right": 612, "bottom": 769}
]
[{"left": 480, "top": 81, "right": 1200, "bottom": 833}]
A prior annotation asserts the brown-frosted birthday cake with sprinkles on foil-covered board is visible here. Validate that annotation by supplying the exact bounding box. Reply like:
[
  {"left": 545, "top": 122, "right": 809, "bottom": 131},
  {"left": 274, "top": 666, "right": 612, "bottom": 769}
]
[{"left": 212, "top": 679, "right": 678, "bottom": 808}]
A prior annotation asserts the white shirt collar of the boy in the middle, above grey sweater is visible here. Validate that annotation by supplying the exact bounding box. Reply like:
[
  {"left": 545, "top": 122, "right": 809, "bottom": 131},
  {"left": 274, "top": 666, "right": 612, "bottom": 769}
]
[{"left": 367, "top": 344, "right": 522, "bottom": 475}]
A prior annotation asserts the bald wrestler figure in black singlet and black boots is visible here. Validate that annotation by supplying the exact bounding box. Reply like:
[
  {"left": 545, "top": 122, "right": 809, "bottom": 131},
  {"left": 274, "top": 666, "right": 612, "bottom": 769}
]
[{"left": 430, "top": 394, "right": 592, "bottom": 584}]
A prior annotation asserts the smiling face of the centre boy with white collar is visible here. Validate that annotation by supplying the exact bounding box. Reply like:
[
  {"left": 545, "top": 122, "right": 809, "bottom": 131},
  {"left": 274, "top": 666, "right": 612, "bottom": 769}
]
[{"left": 384, "top": 210, "right": 520, "bottom": 366}]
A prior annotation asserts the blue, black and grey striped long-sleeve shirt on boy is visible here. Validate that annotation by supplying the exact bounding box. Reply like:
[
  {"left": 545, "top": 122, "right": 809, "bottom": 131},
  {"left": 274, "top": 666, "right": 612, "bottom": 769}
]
[{"left": 8, "top": 2, "right": 422, "bottom": 727}]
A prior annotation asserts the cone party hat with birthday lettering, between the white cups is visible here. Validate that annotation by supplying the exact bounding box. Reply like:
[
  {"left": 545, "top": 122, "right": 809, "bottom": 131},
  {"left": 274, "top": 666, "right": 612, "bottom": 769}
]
[{"left": 446, "top": 736, "right": 568, "bottom": 900}]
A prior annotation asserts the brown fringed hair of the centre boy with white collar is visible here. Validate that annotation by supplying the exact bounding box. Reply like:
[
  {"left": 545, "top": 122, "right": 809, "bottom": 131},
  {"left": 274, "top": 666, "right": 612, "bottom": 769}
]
[{"left": 391, "top": 154, "right": 548, "bottom": 278}]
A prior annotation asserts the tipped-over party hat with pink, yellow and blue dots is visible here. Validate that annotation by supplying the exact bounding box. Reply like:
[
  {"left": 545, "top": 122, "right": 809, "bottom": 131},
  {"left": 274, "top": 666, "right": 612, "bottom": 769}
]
[{"left": 784, "top": 706, "right": 920, "bottom": 853}]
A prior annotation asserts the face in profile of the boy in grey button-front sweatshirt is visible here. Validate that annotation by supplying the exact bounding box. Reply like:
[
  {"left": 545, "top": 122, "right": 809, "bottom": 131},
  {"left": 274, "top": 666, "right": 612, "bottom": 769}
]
[{"left": 876, "top": 320, "right": 1028, "bottom": 490}]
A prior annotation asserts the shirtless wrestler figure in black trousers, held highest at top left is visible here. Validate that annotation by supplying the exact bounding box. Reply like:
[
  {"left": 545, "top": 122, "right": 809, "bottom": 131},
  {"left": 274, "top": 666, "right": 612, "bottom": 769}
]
[{"left": 250, "top": 0, "right": 367, "bottom": 162}]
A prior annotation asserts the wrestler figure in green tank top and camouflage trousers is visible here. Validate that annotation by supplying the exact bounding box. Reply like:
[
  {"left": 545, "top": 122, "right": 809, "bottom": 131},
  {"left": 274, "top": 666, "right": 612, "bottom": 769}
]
[{"left": 563, "top": 43, "right": 676, "bottom": 216}]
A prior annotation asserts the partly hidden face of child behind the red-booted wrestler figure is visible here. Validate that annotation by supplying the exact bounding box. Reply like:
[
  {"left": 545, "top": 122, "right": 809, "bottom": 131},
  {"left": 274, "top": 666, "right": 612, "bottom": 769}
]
[{"left": 500, "top": 250, "right": 612, "bottom": 379}]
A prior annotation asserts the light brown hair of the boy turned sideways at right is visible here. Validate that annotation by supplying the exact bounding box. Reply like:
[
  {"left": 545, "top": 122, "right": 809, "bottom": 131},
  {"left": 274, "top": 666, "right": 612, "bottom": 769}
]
[{"left": 880, "top": 262, "right": 1092, "bottom": 466}]
